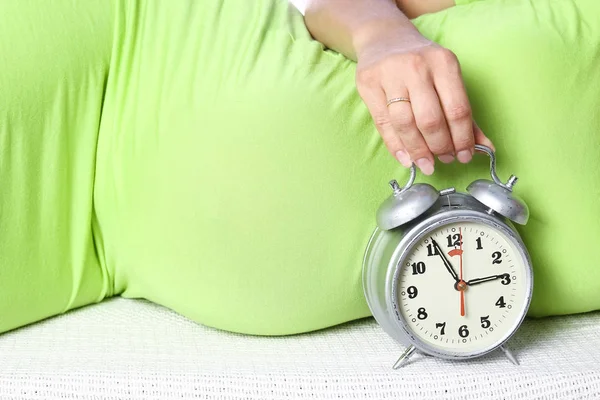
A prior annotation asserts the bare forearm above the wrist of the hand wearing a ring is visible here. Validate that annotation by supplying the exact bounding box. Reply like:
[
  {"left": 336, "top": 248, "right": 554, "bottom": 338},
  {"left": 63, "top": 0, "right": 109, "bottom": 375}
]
[{"left": 304, "top": 0, "right": 416, "bottom": 61}]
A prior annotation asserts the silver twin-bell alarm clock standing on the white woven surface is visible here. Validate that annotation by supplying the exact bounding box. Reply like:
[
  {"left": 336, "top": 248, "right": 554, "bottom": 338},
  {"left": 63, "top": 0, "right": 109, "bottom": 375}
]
[{"left": 363, "top": 145, "right": 533, "bottom": 368}]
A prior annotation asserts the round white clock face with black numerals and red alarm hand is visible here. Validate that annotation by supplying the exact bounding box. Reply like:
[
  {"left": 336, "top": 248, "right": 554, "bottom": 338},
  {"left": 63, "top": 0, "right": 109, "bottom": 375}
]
[{"left": 398, "top": 222, "right": 529, "bottom": 354}]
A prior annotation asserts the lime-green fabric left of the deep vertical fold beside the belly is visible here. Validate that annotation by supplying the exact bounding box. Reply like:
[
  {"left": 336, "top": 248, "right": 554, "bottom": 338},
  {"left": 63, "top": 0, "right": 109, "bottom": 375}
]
[{"left": 0, "top": 0, "right": 114, "bottom": 332}]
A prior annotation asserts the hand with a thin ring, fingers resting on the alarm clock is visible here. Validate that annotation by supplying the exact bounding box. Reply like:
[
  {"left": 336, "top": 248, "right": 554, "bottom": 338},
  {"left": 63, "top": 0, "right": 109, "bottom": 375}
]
[{"left": 356, "top": 23, "right": 494, "bottom": 175}]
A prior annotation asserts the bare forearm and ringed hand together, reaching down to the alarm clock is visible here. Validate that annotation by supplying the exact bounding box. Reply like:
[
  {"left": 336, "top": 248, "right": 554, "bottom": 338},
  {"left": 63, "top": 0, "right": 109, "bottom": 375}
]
[{"left": 305, "top": 0, "right": 493, "bottom": 175}]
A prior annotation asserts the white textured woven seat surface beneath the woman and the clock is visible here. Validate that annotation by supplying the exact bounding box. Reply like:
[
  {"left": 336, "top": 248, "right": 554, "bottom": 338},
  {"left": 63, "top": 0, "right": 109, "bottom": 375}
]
[{"left": 0, "top": 299, "right": 600, "bottom": 400}]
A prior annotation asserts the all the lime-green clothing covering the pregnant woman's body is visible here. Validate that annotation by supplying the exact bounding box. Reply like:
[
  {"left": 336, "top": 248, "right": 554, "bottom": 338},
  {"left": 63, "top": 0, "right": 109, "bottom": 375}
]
[{"left": 0, "top": 0, "right": 600, "bottom": 334}]
